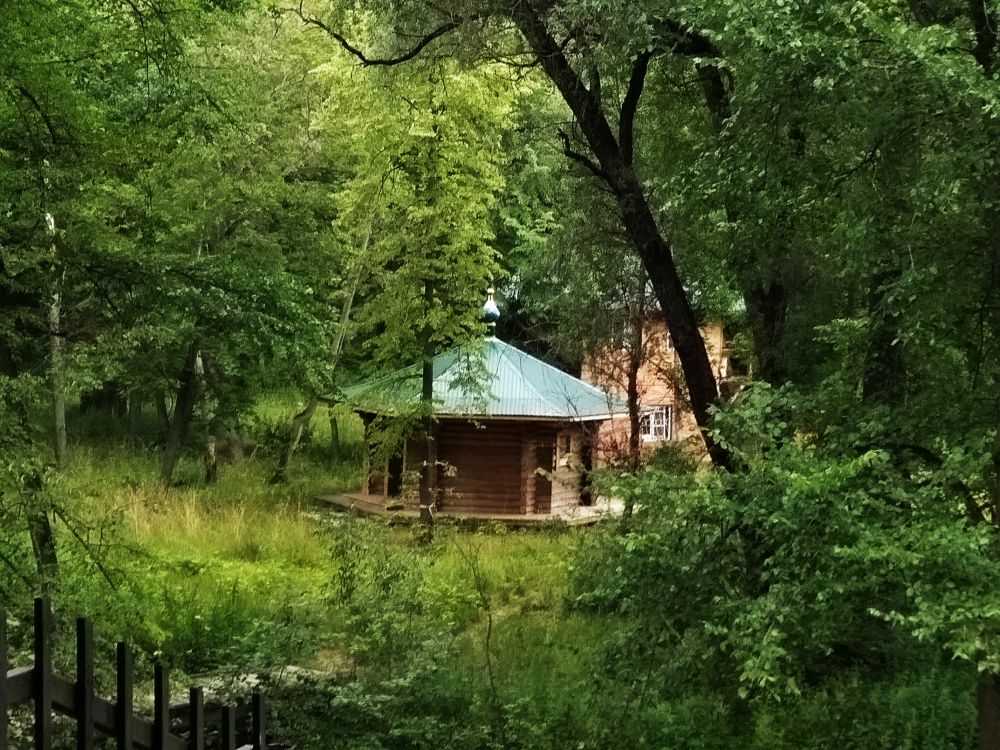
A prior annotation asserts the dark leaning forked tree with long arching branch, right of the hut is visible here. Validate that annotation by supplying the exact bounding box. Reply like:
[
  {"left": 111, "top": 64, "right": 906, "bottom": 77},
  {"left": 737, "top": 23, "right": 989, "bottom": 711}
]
[{"left": 298, "top": 2, "right": 740, "bottom": 466}]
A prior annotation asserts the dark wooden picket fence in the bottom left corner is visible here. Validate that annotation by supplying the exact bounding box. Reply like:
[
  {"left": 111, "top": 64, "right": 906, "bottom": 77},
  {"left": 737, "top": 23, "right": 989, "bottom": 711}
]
[{"left": 0, "top": 599, "right": 267, "bottom": 750}]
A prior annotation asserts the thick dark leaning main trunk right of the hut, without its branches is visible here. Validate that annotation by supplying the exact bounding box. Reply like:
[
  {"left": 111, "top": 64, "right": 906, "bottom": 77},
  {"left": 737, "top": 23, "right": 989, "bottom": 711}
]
[{"left": 511, "top": 1, "right": 731, "bottom": 468}]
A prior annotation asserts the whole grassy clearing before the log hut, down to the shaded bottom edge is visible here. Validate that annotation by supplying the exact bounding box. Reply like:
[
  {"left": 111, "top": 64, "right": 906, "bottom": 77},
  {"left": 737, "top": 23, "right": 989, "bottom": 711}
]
[{"left": 39, "top": 398, "right": 971, "bottom": 750}]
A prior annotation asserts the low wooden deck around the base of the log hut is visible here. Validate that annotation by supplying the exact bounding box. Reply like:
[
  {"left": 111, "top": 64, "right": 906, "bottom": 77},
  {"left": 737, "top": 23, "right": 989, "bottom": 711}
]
[{"left": 316, "top": 492, "right": 621, "bottom": 526}]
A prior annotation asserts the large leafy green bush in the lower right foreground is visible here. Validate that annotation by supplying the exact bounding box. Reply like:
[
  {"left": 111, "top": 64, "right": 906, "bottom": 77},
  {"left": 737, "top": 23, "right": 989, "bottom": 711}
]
[{"left": 572, "top": 387, "right": 998, "bottom": 747}]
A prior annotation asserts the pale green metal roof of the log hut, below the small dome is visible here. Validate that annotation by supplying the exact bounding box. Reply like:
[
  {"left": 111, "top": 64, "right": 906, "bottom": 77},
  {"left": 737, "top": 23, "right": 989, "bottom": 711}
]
[{"left": 344, "top": 337, "right": 628, "bottom": 422}]
